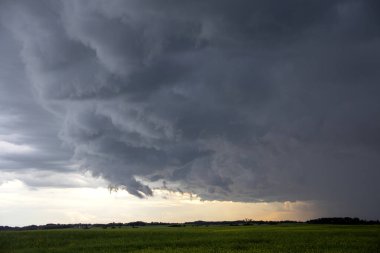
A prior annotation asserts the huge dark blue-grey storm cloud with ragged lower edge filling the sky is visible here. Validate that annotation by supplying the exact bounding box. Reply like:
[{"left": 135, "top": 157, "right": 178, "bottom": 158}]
[{"left": 1, "top": 0, "right": 380, "bottom": 217}]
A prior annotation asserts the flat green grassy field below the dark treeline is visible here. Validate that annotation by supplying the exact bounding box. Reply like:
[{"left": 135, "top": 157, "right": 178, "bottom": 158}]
[{"left": 0, "top": 225, "right": 380, "bottom": 253}]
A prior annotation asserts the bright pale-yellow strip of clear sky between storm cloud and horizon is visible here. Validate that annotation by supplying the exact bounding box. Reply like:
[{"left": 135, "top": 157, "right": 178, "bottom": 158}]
[{"left": 0, "top": 174, "right": 315, "bottom": 226}]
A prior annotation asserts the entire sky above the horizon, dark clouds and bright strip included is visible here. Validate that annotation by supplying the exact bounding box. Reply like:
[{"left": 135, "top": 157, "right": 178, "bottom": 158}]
[{"left": 0, "top": 0, "right": 380, "bottom": 226}]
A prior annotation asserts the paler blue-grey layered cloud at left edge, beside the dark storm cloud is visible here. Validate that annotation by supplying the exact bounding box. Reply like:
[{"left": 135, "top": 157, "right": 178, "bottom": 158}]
[{"left": 0, "top": 22, "right": 70, "bottom": 176}]
